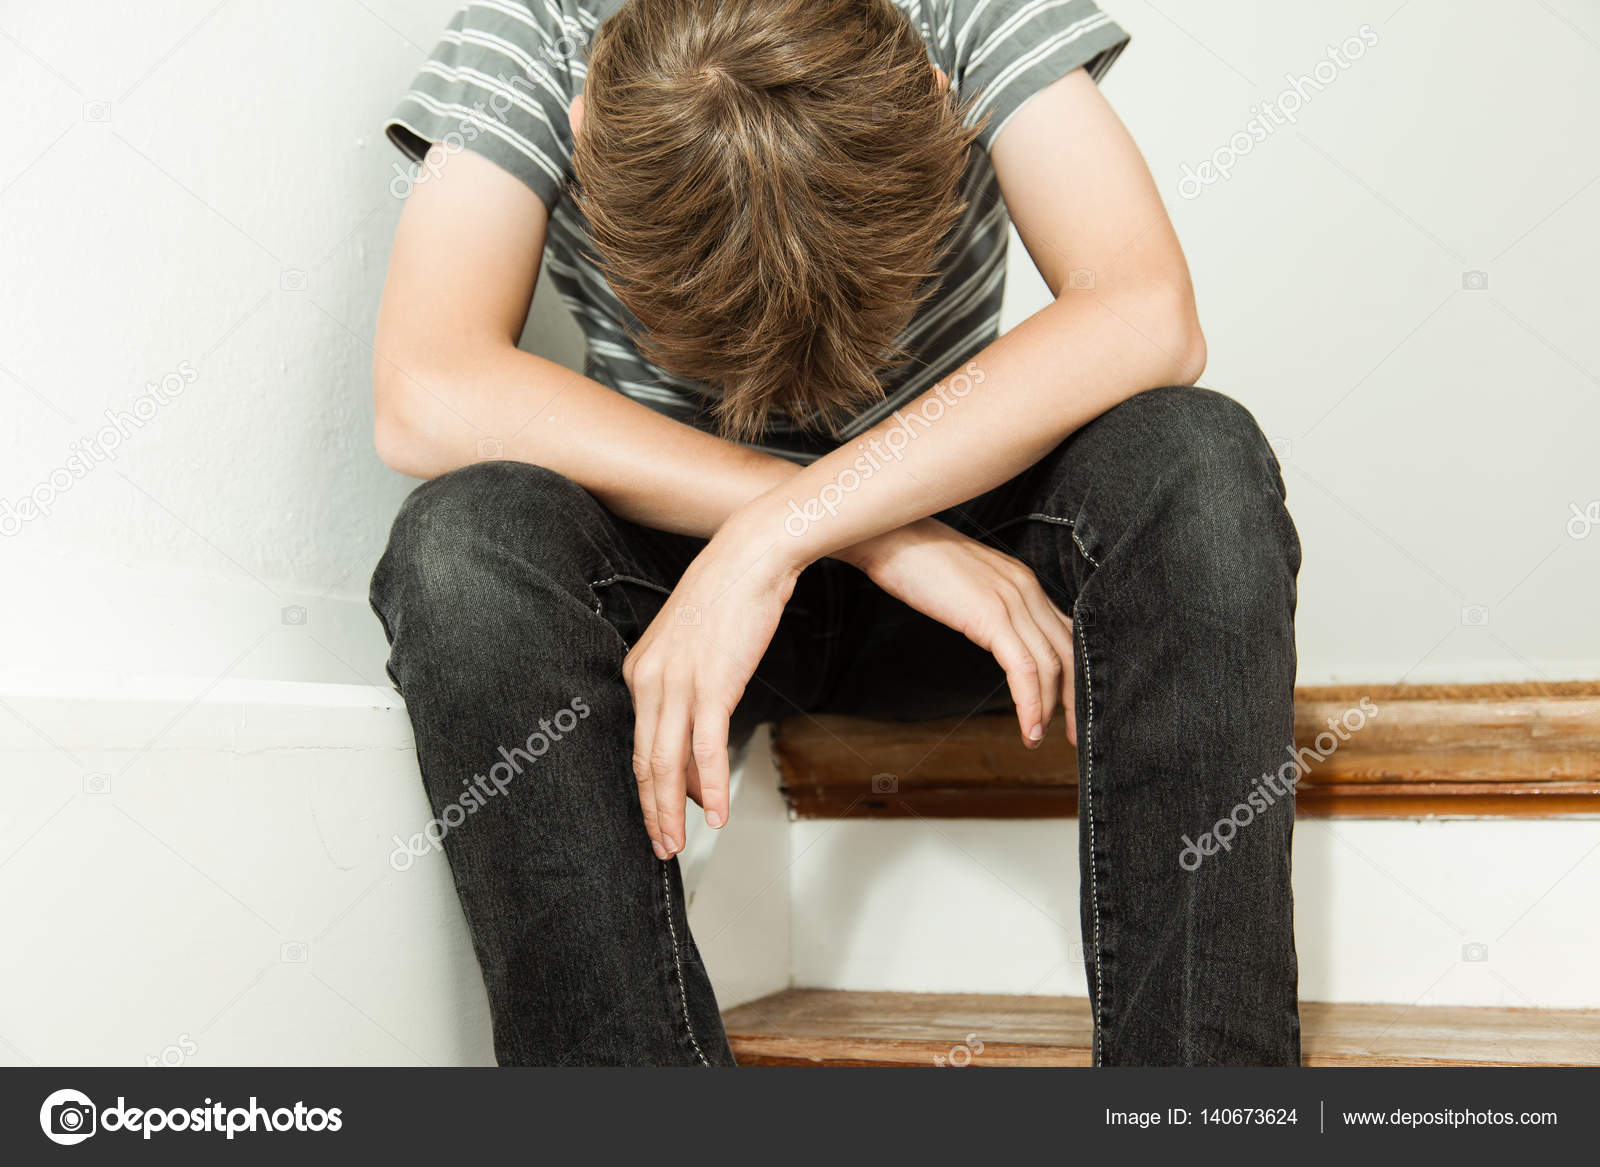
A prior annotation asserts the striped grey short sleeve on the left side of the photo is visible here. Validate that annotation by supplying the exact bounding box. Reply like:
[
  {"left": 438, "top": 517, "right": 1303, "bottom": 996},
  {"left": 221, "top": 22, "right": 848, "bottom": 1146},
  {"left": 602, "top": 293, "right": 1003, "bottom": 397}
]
[{"left": 384, "top": 0, "right": 592, "bottom": 210}]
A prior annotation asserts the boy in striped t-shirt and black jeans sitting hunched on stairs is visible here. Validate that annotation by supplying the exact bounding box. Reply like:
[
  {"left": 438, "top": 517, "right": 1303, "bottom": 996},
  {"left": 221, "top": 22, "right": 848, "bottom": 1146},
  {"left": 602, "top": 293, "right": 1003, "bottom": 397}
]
[{"left": 373, "top": 0, "right": 1299, "bottom": 1065}]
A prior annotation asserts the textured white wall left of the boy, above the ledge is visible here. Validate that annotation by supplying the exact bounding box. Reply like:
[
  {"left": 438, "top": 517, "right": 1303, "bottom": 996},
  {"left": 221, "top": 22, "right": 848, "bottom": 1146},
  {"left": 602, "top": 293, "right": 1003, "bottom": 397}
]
[{"left": 0, "top": 0, "right": 574, "bottom": 682}]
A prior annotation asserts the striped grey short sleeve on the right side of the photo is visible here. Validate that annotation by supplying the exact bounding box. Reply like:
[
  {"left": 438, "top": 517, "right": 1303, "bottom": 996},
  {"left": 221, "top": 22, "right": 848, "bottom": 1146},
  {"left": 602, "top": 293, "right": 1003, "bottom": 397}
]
[{"left": 950, "top": 0, "right": 1128, "bottom": 149}]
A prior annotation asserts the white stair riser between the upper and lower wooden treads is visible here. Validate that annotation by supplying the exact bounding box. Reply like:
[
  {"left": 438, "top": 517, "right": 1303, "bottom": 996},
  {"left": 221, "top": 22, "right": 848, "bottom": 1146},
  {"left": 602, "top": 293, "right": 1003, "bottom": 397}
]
[{"left": 789, "top": 820, "right": 1600, "bottom": 1011}]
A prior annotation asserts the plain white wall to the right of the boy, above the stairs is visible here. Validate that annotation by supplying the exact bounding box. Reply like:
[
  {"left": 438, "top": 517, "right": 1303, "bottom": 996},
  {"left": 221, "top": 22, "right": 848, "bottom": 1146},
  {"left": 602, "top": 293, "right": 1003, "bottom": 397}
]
[{"left": 1010, "top": 0, "right": 1600, "bottom": 684}]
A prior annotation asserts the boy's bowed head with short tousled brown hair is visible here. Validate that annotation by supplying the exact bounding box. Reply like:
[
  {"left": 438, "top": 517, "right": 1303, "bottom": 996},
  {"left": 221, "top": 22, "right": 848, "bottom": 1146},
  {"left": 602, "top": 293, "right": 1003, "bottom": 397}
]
[{"left": 573, "top": 0, "right": 974, "bottom": 437}]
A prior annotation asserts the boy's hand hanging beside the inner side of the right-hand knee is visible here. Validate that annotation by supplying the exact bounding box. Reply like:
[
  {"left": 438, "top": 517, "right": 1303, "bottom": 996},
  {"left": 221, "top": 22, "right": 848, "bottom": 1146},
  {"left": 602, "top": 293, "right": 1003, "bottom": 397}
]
[{"left": 838, "top": 519, "right": 1078, "bottom": 748}]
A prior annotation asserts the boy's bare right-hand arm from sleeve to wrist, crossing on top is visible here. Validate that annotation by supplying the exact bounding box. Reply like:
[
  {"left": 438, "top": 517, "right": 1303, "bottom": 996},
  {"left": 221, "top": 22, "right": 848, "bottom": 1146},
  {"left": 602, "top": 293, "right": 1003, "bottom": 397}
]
[{"left": 744, "top": 69, "right": 1205, "bottom": 563}]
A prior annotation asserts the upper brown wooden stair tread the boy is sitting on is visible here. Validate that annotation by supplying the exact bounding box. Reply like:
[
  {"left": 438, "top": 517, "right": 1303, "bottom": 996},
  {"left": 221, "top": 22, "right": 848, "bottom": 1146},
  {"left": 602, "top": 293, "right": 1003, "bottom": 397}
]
[{"left": 773, "top": 682, "right": 1600, "bottom": 818}]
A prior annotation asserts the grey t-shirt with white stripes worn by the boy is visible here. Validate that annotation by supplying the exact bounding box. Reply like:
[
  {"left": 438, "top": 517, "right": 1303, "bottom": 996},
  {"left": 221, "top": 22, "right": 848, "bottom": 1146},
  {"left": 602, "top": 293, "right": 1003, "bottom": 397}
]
[{"left": 386, "top": 0, "right": 1128, "bottom": 461}]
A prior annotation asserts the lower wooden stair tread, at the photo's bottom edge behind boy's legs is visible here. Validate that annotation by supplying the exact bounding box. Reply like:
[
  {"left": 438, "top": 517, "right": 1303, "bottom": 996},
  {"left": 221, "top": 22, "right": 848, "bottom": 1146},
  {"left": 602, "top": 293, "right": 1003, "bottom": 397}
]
[{"left": 723, "top": 989, "right": 1600, "bottom": 1066}]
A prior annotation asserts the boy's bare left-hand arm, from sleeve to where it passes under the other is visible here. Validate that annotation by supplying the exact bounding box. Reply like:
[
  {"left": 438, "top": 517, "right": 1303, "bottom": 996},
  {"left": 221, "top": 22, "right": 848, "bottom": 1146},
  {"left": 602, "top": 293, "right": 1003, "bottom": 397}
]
[{"left": 373, "top": 152, "right": 797, "bottom": 538}]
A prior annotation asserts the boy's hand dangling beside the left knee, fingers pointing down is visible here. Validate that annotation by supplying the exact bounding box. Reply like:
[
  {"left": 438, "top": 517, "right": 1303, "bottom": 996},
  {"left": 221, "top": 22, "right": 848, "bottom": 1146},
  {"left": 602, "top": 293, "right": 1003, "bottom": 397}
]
[{"left": 622, "top": 515, "right": 800, "bottom": 860}]
